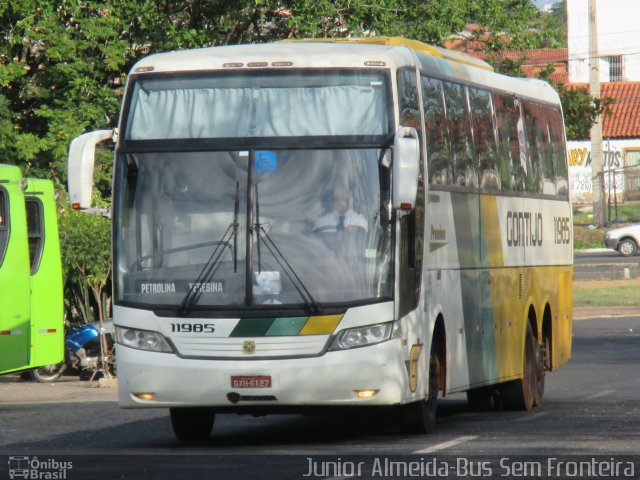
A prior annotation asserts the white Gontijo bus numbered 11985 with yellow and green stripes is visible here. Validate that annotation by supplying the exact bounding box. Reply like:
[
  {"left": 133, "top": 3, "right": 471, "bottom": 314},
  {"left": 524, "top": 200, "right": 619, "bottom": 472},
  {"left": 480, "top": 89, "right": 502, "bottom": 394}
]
[{"left": 69, "top": 38, "right": 573, "bottom": 440}]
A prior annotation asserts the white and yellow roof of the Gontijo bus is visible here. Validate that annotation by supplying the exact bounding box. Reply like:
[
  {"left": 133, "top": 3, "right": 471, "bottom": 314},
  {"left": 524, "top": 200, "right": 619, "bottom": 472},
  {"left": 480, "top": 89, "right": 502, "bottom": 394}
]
[{"left": 131, "top": 37, "right": 559, "bottom": 104}]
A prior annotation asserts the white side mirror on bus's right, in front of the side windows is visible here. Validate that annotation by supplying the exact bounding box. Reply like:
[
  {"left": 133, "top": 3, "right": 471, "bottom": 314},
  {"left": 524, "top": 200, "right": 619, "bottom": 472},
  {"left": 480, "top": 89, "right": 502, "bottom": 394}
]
[{"left": 393, "top": 127, "right": 420, "bottom": 211}]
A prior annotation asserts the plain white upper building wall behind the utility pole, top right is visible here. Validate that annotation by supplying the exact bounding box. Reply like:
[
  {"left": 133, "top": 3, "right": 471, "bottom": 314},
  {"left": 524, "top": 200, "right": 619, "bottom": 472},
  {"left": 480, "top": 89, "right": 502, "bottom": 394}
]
[{"left": 567, "top": 0, "right": 640, "bottom": 83}]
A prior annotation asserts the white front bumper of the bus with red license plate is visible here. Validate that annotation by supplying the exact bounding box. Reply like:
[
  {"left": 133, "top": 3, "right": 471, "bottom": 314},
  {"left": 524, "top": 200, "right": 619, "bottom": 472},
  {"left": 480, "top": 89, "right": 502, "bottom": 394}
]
[{"left": 118, "top": 339, "right": 409, "bottom": 410}]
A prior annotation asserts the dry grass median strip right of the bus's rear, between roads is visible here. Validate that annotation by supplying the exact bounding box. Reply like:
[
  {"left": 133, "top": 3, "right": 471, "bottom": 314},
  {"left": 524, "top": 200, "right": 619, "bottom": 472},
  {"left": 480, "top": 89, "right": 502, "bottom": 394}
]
[{"left": 573, "top": 278, "right": 640, "bottom": 307}]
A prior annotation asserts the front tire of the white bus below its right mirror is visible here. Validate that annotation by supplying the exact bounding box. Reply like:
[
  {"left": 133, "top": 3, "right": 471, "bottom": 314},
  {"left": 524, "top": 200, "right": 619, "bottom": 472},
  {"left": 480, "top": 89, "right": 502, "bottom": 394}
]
[{"left": 400, "top": 346, "right": 440, "bottom": 434}]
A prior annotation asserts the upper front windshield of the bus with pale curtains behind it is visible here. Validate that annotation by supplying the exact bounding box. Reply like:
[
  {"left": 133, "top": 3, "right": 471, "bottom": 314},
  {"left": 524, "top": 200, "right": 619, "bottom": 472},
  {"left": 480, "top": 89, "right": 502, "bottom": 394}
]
[{"left": 124, "top": 69, "right": 391, "bottom": 141}]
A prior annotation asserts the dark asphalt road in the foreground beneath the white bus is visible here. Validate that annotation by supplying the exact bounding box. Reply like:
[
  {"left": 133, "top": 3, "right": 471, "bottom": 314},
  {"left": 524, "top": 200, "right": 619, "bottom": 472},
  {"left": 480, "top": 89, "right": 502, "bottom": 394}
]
[{"left": 0, "top": 317, "right": 640, "bottom": 479}]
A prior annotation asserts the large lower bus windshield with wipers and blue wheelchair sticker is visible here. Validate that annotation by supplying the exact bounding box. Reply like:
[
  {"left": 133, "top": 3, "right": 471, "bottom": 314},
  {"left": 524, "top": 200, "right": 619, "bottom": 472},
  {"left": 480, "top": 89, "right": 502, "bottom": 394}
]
[{"left": 115, "top": 148, "right": 393, "bottom": 311}]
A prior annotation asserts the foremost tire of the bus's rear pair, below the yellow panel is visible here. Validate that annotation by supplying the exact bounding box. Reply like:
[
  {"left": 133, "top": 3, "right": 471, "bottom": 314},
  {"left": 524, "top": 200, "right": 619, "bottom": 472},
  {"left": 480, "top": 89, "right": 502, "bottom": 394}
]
[{"left": 500, "top": 323, "right": 541, "bottom": 411}]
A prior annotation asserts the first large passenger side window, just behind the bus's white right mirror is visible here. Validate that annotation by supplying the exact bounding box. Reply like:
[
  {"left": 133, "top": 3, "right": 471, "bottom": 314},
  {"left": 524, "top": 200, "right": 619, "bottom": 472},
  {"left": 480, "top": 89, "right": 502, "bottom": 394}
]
[{"left": 422, "top": 77, "right": 453, "bottom": 185}]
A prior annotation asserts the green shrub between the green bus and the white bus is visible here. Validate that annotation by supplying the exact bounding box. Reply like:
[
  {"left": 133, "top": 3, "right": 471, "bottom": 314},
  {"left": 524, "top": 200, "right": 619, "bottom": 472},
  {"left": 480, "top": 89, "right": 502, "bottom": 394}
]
[{"left": 59, "top": 206, "right": 111, "bottom": 323}]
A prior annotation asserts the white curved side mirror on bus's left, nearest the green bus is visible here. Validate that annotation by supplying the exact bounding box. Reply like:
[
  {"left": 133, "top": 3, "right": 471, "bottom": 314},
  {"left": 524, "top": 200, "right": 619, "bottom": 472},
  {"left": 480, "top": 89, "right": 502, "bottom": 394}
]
[{"left": 67, "top": 130, "right": 115, "bottom": 210}]
